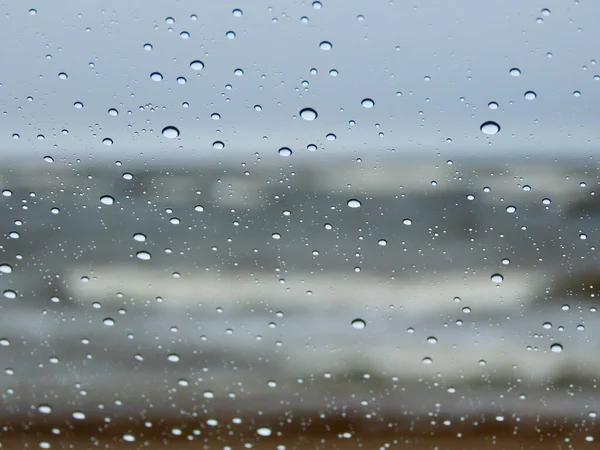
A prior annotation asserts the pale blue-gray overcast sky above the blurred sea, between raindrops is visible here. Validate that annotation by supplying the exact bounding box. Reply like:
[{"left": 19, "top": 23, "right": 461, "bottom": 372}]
[{"left": 0, "top": 0, "right": 600, "bottom": 163}]
